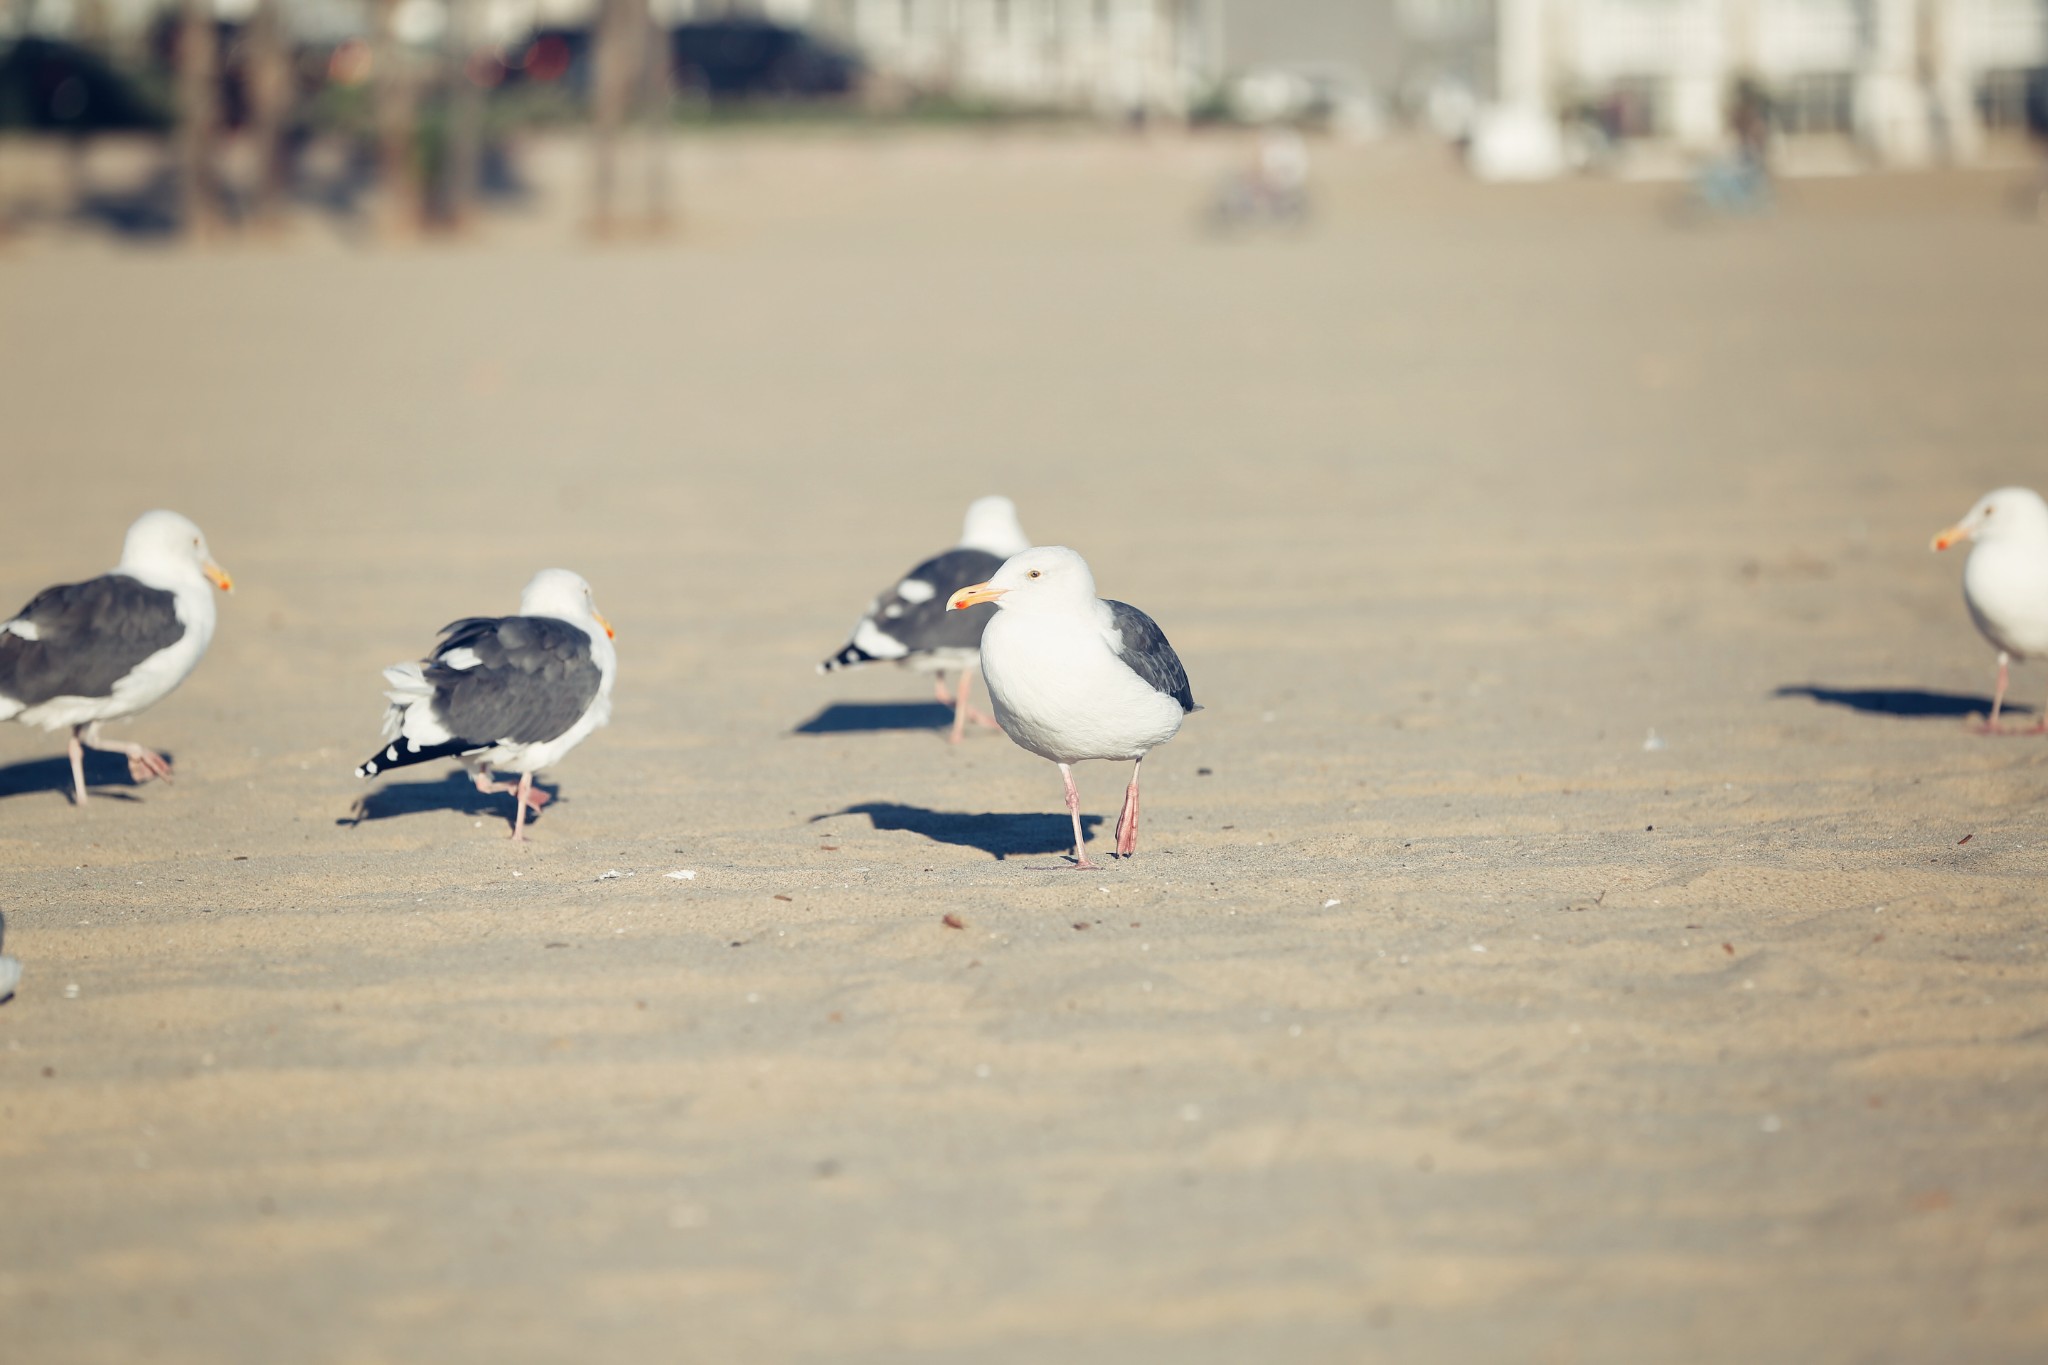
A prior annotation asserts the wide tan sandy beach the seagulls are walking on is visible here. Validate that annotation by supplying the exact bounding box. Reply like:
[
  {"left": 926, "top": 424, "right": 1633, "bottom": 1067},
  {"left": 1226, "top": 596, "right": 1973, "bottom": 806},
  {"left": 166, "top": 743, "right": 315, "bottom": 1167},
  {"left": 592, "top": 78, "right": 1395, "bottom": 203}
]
[{"left": 0, "top": 135, "right": 2048, "bottom": 1365}]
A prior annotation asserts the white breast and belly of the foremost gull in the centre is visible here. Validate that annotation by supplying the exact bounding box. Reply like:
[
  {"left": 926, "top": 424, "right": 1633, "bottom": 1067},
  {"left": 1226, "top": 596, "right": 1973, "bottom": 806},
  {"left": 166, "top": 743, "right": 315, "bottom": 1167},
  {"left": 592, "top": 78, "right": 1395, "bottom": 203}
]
[{"left": 981, "top": 610, "right": 1184, "bottom": 763}]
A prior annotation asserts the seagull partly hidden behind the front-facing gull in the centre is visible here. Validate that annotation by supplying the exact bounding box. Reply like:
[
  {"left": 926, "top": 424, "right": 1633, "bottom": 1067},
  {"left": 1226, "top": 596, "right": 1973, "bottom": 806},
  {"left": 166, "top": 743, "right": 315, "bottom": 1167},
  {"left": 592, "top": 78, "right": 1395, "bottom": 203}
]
[{"left": 817, "top": 497, "right": 1030, "bottom": 743}]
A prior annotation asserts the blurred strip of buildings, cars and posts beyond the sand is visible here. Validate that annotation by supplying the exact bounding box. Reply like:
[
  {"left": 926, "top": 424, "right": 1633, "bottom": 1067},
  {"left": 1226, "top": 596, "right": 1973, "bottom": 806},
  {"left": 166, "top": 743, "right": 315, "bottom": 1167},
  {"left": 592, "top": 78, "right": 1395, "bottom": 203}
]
[{"left": 0, "top": 0, "right": 2048, "bottom": 239}]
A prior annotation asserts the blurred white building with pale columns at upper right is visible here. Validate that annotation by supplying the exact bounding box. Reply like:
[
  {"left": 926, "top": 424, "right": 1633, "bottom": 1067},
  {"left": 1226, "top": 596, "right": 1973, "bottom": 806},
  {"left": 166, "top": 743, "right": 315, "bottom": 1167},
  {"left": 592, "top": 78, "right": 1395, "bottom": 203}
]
[{"left": 1474, "top": 0, "right": 2048, "bottom": 166}]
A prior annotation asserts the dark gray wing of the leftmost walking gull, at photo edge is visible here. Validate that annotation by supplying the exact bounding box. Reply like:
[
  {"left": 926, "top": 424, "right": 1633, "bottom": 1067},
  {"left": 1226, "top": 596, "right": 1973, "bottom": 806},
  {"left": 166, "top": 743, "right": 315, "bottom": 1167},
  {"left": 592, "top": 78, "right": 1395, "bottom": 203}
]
[{"left": 0, "top": 573, "right": 184, "bottom": 706}]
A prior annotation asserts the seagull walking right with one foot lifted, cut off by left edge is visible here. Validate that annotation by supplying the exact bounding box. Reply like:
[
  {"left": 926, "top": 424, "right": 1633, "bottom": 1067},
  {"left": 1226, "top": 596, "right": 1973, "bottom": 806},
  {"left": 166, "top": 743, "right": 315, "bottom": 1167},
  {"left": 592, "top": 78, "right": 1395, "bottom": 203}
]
[{"left": 0, "top": 510, "right": 233, "bottom": 806}]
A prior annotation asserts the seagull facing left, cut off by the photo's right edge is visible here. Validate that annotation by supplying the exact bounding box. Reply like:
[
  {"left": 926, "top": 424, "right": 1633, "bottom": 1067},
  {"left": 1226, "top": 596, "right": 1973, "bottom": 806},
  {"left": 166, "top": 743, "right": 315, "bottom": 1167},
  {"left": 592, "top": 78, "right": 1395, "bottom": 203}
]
[{"left": 1933, "top": 487, "right": 2048, "bottom": 735}]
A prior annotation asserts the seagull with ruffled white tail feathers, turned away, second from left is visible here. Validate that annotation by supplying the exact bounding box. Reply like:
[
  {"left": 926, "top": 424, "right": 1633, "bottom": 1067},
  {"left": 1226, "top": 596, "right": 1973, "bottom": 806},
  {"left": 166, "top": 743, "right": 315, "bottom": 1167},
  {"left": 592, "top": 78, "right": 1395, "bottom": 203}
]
[{"left": 356, "top": 569, "right": 618, "bottom": 843}]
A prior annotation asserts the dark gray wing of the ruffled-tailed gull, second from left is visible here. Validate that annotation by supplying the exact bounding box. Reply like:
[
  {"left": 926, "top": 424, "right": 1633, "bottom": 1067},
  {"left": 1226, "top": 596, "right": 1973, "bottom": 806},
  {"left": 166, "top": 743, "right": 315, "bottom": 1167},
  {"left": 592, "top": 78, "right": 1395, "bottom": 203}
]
[{"left": 422, "top": 616, "right": 604, "bottom": 747}]
